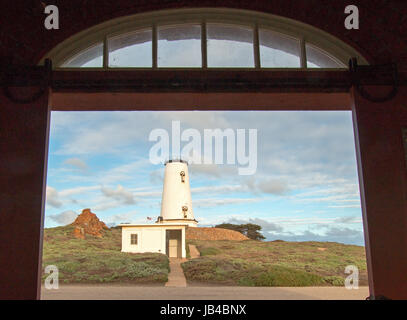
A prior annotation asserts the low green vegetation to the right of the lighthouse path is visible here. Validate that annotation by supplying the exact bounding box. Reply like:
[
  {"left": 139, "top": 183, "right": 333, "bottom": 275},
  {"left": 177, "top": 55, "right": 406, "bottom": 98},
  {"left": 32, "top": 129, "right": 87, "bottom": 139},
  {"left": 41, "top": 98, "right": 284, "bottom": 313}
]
[{"left": 182, "top": 240, "right": 367, "bottom": 286}]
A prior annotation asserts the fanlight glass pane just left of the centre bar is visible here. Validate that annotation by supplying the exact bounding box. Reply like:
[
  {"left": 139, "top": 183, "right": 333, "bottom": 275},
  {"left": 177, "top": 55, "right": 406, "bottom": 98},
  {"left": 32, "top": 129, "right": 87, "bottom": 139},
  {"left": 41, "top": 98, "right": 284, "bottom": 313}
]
[{"left": 157, "top": 24, "right": 202, "bottom": 67}]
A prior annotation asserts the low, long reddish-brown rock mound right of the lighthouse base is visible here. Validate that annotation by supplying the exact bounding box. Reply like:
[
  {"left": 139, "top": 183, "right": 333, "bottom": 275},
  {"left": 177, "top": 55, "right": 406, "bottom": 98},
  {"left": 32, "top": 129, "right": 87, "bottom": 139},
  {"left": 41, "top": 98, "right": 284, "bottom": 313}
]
[{"left": 185, "top": 227, "right": 249, "bottom": 241}]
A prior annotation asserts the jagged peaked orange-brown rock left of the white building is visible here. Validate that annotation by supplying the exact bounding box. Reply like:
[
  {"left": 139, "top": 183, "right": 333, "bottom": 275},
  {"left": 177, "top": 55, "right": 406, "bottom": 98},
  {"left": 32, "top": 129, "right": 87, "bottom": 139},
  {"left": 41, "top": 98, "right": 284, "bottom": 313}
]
[{"left": 72, "top": 209, "right": 109, "bottom": 239}]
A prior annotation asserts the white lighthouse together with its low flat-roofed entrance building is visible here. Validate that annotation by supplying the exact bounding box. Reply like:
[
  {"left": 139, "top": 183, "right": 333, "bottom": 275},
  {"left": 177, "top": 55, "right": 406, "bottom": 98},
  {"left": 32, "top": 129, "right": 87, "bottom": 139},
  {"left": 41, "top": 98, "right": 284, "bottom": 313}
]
[{"left": 119, "top": 160, "right": 198, "bottom": 258}]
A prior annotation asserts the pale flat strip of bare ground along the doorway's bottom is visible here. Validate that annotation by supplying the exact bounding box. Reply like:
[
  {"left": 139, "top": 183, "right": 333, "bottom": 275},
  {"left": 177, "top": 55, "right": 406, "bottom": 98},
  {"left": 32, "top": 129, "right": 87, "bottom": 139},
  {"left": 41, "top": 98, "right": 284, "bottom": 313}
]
[{"left": 41, "top": 285, "right": 369, "bottom": 300}]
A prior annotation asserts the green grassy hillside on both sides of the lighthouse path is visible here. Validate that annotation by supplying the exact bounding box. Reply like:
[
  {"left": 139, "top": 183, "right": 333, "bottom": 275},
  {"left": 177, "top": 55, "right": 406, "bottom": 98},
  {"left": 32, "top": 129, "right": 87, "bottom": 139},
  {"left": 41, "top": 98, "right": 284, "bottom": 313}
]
[{"left": 43, "top": 225, "right": 367, "bottom": 286}]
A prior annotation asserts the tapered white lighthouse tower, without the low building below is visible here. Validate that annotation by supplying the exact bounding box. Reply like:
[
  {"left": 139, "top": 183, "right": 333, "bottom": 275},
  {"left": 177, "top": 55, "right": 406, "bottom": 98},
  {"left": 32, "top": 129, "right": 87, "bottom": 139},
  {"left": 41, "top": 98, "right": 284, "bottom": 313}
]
[{"left": 157, "top": 160, "right": 198, "bottom": 227}]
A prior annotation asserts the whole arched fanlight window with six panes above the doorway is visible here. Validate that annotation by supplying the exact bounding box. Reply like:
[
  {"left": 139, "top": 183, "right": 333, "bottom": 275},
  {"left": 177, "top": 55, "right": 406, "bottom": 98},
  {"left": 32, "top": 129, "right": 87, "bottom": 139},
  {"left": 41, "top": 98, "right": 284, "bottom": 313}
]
[{"left": 51, "top": 13, "right": 364, "bottom": 70}]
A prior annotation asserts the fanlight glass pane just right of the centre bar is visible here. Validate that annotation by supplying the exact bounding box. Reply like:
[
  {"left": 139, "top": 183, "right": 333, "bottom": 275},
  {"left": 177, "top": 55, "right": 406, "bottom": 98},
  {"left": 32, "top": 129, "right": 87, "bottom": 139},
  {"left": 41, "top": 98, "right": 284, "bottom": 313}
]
[{"left": 207, "top": 23, "right": 254, "bottom": 67}]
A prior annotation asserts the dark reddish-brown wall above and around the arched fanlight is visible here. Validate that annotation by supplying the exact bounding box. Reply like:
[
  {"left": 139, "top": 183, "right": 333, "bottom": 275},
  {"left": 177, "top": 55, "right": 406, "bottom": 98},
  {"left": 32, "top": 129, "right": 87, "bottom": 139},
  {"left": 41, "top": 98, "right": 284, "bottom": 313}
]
[{"left": 0, "top": 0, "right": 407, "bottom": 70}]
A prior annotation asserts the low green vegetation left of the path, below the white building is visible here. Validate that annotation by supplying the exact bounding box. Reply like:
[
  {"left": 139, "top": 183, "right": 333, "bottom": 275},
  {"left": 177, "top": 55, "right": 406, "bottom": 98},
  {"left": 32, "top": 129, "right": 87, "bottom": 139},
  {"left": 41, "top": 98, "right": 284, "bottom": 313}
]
[{"left": 42, "top": 226, "right": 169, "bottom": 283}]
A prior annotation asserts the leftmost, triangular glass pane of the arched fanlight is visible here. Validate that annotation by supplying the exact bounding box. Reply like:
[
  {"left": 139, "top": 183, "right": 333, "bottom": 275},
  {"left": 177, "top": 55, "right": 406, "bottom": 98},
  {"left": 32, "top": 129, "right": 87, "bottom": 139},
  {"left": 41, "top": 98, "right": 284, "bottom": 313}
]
[{"left": 61, "top": 43, "right": 103, "bottom": 68}]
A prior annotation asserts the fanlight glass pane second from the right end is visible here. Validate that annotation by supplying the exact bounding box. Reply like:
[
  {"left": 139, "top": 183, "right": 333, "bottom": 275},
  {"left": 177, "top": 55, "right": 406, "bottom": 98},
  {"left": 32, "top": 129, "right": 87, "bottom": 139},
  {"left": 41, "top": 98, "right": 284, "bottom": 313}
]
[{"left": 259, "top": 29, "right": 301, "bottom": 68}]
